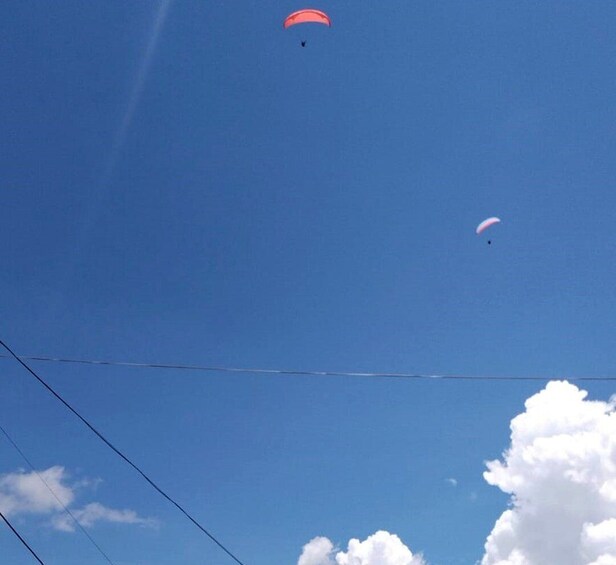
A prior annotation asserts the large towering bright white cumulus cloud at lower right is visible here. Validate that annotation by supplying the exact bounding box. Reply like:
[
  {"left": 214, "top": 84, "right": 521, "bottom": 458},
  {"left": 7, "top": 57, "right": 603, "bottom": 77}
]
[{"left": 481, "top": 381, "right": 616, "bottom": 565}]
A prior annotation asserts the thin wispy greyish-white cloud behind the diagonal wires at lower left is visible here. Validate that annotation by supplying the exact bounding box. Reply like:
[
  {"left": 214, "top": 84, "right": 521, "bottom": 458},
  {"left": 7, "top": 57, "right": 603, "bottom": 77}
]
[{"left": 0, "top": 466, "right": 156, "bottom": 532}]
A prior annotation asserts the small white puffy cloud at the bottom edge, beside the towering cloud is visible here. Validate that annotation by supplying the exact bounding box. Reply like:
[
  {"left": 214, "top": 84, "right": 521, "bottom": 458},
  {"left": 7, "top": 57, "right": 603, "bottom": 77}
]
[{"left": 297, "top": 531, "right": 426, "bottom": 565}]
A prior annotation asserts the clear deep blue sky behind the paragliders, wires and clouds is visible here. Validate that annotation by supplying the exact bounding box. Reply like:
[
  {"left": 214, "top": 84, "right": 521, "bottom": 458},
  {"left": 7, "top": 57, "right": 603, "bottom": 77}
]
[{"left": 0, "top": 0, "right": 616, "bottom": 565}]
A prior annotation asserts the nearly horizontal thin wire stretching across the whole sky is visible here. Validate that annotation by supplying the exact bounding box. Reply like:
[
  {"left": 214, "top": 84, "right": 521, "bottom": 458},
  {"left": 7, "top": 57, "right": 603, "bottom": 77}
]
[{"left": 0, "top": 354, "right": 616, "bottom": 381}]
